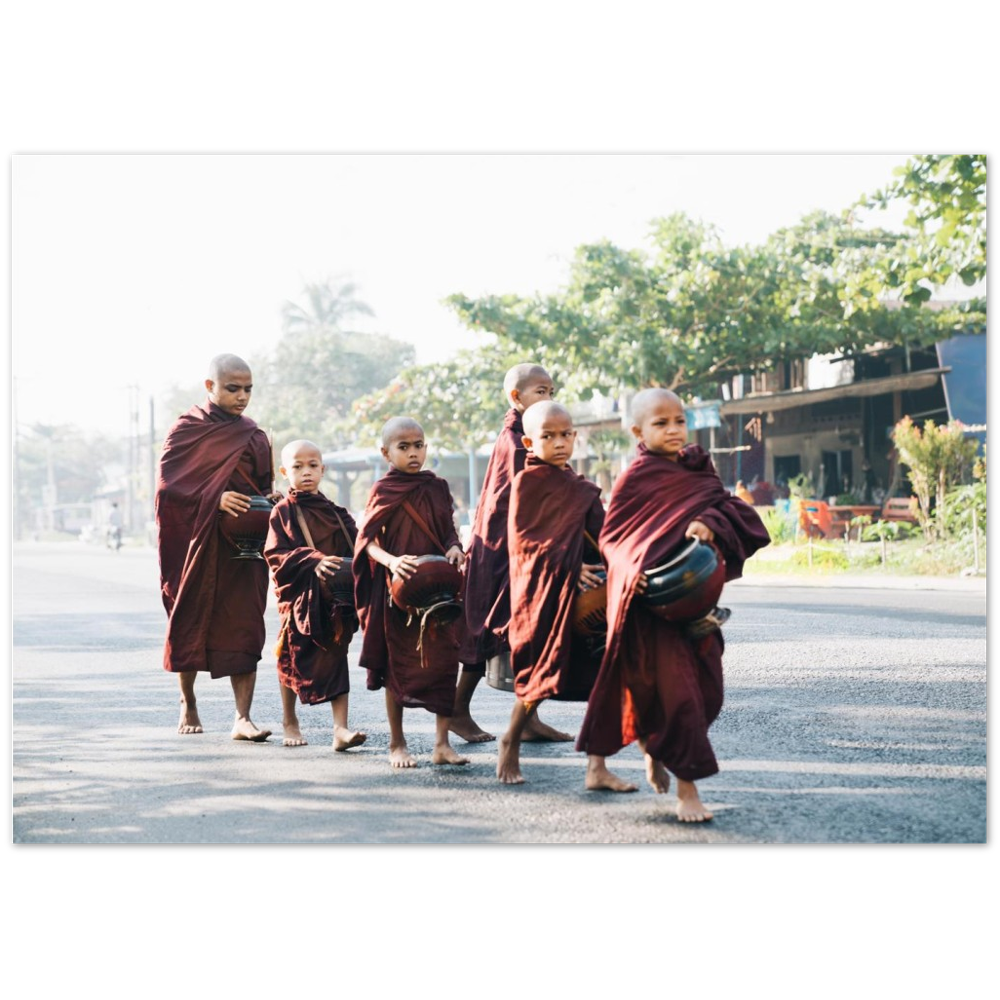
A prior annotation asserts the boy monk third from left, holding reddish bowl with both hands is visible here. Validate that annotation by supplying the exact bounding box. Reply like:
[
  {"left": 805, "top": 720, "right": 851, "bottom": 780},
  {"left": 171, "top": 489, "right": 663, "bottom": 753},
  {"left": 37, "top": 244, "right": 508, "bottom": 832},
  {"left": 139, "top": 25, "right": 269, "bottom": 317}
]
[{"left": 354, "top": 417, "right": 468, "bottom": 768}]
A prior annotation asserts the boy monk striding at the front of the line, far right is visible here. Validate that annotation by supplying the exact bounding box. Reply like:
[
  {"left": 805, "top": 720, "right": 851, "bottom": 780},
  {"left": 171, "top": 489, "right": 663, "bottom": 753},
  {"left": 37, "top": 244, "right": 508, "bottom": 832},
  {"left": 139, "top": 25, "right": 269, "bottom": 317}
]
[{"left": 577, "top": 389, "right": 769, "bottom": 823}]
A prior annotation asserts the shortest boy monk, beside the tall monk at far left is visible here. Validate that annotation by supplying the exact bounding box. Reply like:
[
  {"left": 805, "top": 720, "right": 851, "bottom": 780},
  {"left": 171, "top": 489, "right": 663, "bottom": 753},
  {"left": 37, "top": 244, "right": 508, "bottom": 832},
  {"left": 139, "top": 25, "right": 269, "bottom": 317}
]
[{"left": 264, "top": 441, "right": 367, "bottom": 751}]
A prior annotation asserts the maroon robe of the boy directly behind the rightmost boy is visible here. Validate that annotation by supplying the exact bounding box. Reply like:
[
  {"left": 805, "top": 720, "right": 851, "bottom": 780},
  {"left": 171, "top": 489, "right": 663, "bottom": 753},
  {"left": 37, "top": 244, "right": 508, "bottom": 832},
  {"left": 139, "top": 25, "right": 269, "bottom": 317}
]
[{"left": 508, "top": 455, "right": 604, "bottom": 702}]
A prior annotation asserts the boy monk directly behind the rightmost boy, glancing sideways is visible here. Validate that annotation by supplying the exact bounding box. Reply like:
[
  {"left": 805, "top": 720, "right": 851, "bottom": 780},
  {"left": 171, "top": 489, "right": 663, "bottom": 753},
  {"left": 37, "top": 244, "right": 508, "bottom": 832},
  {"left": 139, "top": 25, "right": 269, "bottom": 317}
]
[{"left": 497, "top": 401, "right": 636, "bottom": 792}]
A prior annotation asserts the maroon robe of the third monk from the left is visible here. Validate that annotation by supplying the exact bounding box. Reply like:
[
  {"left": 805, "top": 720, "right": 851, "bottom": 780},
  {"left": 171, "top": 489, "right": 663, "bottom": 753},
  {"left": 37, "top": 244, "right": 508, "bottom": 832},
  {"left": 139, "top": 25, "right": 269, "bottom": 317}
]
[{"left": 354, "top": 469, "right": 461, "bottom": 715}]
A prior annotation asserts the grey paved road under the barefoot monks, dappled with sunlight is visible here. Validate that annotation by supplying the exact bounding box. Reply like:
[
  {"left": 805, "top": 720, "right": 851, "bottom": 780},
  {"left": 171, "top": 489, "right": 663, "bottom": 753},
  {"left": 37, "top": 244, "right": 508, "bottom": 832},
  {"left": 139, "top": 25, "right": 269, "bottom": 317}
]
[{"left": 12, "top": 543, "right": 986, "bottom": 844}]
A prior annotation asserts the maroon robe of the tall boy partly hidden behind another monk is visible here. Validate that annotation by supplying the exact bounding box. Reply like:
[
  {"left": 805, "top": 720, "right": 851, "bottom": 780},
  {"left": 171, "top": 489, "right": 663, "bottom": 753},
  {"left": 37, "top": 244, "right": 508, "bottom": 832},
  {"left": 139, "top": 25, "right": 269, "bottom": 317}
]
[{"left": 459, "top": 409, "right": 528, "bottom": 670}]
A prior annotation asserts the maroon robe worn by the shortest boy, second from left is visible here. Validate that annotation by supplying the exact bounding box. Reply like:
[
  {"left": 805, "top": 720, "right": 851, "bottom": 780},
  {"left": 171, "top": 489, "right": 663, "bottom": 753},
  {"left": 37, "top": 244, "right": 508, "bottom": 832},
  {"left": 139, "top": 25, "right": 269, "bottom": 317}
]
[{"left": 264, "top": 490, "right": 358, "bottom": 705}]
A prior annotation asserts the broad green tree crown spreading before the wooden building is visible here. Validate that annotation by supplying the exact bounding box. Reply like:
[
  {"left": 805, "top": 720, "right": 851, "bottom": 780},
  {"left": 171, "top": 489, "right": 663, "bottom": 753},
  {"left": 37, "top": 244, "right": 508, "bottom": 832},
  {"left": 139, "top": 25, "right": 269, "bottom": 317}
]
[{"left": 449, "top": 214, "right": 955, "bottom": 398}]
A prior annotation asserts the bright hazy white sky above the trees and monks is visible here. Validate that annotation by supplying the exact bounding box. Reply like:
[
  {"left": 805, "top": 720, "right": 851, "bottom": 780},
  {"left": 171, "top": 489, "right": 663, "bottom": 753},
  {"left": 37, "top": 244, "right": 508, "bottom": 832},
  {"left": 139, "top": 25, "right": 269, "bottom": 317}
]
[{"left": 12, "top": 153, "right": 906, "bottom": 434}]
